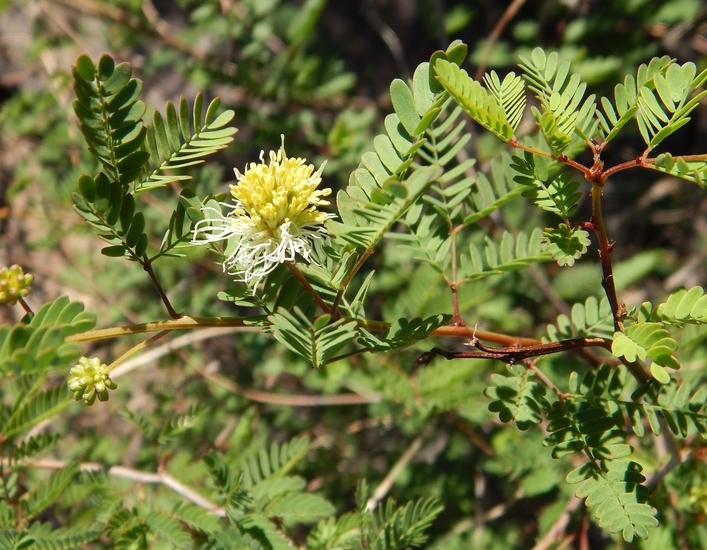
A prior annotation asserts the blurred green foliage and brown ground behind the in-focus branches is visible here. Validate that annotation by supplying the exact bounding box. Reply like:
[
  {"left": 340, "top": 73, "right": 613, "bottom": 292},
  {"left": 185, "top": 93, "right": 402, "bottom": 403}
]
[{"left": 0, "top": 0, "right": 707, "bottom": 550}]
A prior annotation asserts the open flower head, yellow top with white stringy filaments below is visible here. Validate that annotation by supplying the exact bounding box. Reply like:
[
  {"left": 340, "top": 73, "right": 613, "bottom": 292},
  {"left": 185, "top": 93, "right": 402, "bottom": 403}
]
[{"left": 192, "top": 136, "right": 333, "bottom": 292}]
